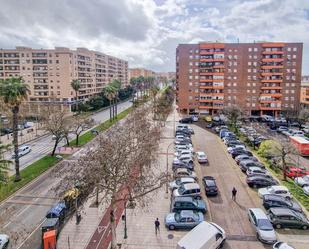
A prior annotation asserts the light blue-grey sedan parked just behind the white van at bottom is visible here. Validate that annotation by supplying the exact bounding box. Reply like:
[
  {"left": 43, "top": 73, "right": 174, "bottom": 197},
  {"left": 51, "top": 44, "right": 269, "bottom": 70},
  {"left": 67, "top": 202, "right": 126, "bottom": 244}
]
[{"left": 165, "top": 210, "right": 204, "bottom": 230}]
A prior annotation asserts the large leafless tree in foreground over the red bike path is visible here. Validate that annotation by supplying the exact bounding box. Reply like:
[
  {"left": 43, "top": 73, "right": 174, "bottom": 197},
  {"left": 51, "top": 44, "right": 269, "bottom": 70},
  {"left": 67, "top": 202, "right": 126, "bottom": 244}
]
[{"left": 54, "top": 107, "right": 167, "bottom": 249}]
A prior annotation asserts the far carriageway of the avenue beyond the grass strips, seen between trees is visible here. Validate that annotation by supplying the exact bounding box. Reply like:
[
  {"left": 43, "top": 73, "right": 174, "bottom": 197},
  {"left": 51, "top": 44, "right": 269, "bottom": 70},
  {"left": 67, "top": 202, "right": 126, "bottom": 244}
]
[{"left": 5, "top": 101, "right": 132, "bottom": 174}]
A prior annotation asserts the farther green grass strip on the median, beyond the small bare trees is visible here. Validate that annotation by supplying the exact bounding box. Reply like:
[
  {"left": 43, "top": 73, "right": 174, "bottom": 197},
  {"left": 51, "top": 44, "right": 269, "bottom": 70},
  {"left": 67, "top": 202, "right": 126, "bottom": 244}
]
[{"left": 70, "top": 107, "right": 132, "bottom": 147}]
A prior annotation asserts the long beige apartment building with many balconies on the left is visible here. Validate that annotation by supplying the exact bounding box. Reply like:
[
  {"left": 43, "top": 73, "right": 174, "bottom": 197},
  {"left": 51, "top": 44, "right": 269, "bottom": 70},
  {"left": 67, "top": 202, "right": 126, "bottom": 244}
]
[{"left": 0, "top": 47, "right": 128, "bottom": 105}]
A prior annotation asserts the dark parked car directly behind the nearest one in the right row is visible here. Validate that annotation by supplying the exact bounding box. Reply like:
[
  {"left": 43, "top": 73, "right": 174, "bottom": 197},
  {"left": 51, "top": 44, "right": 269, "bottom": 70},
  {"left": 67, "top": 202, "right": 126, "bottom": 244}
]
[{"left": 263, "top": 195, "right": 302, "bottom": 212}]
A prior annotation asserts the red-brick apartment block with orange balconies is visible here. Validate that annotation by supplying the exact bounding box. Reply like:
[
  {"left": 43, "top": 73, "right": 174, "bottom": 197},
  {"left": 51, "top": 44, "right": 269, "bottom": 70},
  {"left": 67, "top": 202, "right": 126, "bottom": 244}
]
[{"left": 176, "top": 42, "right": 303, "bottom": 115}]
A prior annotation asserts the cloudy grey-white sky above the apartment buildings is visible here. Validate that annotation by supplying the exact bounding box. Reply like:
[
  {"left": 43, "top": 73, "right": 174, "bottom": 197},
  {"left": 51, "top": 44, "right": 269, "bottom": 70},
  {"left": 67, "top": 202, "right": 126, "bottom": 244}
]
[{"left": 0, "top": 0, "right": 309, "bottom": 74}]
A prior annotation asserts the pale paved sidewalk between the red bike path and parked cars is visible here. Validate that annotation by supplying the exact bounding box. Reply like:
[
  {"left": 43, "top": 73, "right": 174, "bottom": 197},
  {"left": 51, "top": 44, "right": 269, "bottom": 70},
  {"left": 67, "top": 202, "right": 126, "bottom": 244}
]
[{"left": 117, "top": 108, "right": 187, "bottom": 249}]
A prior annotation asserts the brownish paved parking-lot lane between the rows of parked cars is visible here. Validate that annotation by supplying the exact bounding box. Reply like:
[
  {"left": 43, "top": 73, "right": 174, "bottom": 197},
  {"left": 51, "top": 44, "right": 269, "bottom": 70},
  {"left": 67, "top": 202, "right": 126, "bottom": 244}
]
[{"left": 193, "top": 125, "right": 309, "bottom": 249}]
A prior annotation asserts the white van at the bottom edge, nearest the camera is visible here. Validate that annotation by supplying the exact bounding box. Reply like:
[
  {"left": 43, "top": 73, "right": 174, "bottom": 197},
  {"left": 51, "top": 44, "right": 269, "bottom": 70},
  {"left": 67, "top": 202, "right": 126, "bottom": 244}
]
[{"left": 176, "top": 221, "right": 226, "bottom": 249}]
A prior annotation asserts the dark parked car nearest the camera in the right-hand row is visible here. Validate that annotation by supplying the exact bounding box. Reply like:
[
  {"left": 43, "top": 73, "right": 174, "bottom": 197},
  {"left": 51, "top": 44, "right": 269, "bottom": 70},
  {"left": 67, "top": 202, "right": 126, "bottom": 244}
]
[{"left": 268, "top": 207, "right": 309, "bottom": 230}]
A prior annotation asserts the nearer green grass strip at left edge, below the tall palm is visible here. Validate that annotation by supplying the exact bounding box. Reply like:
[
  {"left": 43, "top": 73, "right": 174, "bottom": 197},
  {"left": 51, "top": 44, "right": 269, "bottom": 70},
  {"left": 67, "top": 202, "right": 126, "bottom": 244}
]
[{"left": 0, "top": 156, "right": 61, "bottom": 202}]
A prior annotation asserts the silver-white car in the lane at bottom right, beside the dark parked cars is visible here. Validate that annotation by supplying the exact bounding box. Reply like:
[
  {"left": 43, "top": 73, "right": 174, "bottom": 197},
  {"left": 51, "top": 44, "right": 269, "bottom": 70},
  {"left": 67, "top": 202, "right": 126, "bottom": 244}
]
[{"left": 248, "top": 208, "right": 277, "bottom": 244}]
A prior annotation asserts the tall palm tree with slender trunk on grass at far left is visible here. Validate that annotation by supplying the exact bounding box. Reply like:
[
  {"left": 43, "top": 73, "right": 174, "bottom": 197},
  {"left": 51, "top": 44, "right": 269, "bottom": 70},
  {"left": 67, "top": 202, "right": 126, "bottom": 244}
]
[{"left": 0, "top": 77, "right": 29, "bottom": 181}]
